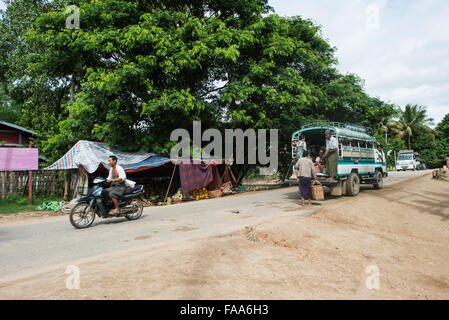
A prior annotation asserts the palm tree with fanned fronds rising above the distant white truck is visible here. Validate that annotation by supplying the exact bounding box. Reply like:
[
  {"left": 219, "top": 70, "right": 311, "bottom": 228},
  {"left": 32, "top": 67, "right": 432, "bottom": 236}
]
[{"left": 389, "top": 104, "right": 434, "bottom": 149}]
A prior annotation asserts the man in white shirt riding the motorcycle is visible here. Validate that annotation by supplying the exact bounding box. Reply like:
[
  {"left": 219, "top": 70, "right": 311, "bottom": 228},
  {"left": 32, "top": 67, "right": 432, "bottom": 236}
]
[{"left": 103, "top": 156, "right": 126, "bottom": 215}]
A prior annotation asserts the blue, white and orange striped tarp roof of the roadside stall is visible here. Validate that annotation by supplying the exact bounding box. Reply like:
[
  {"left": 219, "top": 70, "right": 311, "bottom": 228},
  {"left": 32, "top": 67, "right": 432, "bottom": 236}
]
[{"left": 44, "top": 140, "right": 171, "bottom": 173}]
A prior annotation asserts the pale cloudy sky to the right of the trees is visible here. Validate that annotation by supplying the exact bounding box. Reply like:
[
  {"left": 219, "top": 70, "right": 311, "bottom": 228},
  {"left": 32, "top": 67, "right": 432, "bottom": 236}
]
[{"left": 269, "top": 0, "right": 449, "bottom": 124}]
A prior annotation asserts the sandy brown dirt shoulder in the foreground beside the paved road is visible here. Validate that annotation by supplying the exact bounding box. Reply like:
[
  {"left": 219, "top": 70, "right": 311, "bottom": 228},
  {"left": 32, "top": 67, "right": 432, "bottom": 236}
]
[{"left": 0, "top": 176, "right": 449, "bottom": 299}]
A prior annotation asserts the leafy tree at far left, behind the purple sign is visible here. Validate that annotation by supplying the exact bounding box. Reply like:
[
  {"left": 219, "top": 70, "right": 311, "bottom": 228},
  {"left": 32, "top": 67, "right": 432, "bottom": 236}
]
[{"left": 0, "top": 0, "right": 67, "bottom": 147}]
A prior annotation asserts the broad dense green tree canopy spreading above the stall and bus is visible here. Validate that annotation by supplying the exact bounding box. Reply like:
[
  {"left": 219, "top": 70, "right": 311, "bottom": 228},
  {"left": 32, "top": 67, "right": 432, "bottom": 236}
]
[{"left": 0, "top": 0, "right": 444, "bottom": 175}]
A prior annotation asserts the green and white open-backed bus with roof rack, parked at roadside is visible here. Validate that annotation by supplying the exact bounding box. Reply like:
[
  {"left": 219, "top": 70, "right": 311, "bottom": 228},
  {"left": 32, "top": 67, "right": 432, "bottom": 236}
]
[{"left": 285, "top": 122, "right": 388, "bottom": 196}]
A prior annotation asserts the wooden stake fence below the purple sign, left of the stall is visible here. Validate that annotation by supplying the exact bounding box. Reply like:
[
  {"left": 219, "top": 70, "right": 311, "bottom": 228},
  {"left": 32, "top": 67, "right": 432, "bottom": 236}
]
[{"left": 0, "top": 170, "right": 77, "bottom": 199}]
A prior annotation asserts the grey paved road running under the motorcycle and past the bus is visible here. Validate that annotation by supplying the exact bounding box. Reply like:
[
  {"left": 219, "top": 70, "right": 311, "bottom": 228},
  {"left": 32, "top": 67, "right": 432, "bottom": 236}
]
[{"left": 0, "top": 171, "right": 430, "bottom": 281}]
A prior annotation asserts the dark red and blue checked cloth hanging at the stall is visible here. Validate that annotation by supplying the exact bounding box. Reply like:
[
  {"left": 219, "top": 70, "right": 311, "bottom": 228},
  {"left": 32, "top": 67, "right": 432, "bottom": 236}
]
[{"left": 179, "top": 162, "right": 214, "bottom": 193}]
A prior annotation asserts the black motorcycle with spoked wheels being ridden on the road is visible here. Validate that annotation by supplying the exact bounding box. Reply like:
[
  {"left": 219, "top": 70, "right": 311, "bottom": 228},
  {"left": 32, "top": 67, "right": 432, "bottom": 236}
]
[{"left": 70, "top": 177, "right": 143, "bottom": 229}]
